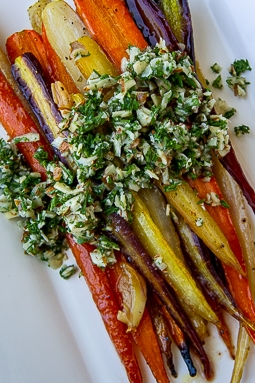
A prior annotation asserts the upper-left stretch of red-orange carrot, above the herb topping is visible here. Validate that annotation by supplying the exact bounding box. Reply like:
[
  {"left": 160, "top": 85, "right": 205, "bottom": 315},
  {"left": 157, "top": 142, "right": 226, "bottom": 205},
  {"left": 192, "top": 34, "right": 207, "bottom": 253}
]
[{"left": 0, "top": 71, "right": 52, "bottom": 180}]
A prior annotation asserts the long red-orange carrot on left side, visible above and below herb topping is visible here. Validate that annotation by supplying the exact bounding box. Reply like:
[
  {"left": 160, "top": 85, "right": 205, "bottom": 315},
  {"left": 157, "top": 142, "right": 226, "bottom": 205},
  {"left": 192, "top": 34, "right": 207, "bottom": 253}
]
[{"left": 0, "top": 54, "right": 142, "bottom": 383}]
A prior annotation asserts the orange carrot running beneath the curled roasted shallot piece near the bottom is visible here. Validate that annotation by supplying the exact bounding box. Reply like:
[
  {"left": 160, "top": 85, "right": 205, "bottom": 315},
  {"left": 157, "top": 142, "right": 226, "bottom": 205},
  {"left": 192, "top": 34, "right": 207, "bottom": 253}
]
[{"left": 107, "top": 256, "right": 169, "bottom": 383}]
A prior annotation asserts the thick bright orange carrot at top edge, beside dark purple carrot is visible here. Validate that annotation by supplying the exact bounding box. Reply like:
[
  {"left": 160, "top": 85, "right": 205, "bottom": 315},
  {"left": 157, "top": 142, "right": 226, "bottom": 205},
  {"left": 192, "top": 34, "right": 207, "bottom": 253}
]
[{"left": 74, "top": 0, "right": 148, "bottom": 69}]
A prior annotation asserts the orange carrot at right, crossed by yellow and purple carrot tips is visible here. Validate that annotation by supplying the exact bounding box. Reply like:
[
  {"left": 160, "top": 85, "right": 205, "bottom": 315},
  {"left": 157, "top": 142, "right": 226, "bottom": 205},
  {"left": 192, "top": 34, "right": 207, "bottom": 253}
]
[{"left": 189, "top": 177, "right": 255, "bottom": 343}]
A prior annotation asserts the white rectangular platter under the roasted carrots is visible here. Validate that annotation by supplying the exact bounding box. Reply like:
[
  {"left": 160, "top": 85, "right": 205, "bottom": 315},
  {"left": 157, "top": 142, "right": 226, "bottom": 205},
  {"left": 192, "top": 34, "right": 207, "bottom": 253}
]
[{"left": 0, "top": 0, "right": 255, "bottom": 383}]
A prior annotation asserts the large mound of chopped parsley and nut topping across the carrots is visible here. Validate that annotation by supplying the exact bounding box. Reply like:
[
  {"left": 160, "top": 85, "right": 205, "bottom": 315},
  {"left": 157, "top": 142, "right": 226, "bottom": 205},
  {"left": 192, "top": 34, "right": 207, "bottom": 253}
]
[{"left": 0, "top": 40, "right": 230, "bottom": 270}]
